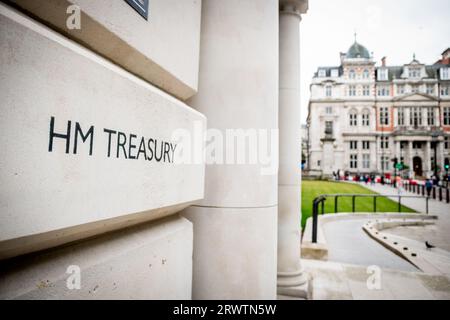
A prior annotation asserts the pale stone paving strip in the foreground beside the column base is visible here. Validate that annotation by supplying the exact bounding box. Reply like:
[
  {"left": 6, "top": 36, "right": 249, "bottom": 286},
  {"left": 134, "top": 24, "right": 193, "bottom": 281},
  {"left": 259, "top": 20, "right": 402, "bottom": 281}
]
[{"left": 302, "top": 259, "right": 450, "bottom": 300}]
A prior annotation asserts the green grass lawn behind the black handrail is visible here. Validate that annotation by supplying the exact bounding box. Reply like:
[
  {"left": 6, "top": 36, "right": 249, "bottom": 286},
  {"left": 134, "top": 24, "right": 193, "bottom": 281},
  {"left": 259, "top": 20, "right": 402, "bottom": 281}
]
[{"left": 302, "top": 181, "right": 415, "bottom": 228}]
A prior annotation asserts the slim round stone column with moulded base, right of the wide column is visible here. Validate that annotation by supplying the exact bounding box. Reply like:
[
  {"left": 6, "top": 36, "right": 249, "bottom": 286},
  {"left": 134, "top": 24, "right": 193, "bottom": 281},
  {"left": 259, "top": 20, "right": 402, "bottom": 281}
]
[{"left": 278, "top": 0, "right": 308, "bottom": 297}]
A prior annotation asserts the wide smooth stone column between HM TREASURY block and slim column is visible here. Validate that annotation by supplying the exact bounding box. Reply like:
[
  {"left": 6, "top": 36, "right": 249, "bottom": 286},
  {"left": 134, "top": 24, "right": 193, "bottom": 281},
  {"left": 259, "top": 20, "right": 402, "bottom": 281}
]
[{"left": 183, "top": 0, "right": 280, "bottom": 299}]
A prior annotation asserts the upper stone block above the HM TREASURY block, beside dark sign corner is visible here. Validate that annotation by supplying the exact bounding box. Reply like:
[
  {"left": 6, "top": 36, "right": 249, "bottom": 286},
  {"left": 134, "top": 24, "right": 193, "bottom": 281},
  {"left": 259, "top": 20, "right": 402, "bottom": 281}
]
[{"left": 7, "top": 0, "right": 201, "bottom": 100}]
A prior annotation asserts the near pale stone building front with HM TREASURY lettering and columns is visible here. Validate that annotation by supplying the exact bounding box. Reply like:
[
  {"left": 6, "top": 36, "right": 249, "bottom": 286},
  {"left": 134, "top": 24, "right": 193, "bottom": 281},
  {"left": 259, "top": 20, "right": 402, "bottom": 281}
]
[{"left": 0, "top": 0, "right": 308, "bottom": 299}]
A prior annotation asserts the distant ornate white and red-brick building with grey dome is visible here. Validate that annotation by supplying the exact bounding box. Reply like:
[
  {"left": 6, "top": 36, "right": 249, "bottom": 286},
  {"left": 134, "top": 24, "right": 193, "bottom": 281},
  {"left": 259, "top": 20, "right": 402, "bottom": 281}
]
[{"left": 308, "top": 40, "right": 450, "bottom": 178}]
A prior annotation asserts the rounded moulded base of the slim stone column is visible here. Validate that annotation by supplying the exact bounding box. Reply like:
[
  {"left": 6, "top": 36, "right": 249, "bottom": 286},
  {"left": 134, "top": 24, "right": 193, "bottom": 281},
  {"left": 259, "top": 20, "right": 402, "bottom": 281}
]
[{"left": 277, "top": 269, "right": 312, "bottom": 299}]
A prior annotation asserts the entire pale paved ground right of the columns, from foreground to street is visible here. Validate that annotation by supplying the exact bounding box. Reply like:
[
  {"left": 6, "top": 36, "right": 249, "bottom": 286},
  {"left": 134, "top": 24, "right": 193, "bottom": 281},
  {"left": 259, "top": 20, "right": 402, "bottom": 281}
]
[{"left": 298, "top": 183, "right": 450, "bottom": 300}]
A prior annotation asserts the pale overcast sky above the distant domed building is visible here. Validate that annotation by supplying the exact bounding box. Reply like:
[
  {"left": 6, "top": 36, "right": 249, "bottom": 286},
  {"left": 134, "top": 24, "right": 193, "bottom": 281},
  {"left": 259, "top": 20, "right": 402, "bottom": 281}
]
[{"left": 300, "top": 0, "right": 450, "bottom": 123}]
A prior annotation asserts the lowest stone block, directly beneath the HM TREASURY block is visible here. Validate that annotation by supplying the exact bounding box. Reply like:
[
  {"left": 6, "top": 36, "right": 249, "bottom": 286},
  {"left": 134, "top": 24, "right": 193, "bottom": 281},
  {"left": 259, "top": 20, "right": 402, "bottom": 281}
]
[{"left": 0, "top": 215, "right": 193, "bottom": 300}]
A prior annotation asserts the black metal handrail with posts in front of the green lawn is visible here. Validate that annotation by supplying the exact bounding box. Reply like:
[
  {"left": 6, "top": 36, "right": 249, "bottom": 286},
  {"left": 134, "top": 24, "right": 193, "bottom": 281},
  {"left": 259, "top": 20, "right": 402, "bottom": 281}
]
[{"left": 312, "top": 194, "right": 429, "bottom": 243}]
